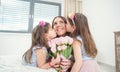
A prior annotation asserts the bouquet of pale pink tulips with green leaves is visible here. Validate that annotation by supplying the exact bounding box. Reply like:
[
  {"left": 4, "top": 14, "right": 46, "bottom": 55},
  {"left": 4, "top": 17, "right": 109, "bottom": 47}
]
[{"left": 48, "top": 36, "right": 73, "bottom": 72}]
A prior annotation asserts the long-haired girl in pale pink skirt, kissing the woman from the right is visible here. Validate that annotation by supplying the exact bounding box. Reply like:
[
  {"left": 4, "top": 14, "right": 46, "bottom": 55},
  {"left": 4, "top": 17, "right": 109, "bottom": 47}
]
[{"left": 66, "top": 13, "right": 100, "bottom": 72}]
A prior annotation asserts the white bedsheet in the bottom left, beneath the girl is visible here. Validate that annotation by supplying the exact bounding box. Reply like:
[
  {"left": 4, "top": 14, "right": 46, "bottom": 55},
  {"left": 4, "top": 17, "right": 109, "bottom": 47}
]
[{"left": 0, "top": 55, "right": 57, "bottom": 72}]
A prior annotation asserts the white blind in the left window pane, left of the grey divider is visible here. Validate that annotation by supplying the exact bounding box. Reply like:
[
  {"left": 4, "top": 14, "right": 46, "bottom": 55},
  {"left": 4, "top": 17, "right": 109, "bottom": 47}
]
[{"left": 0, "top": 0, "right": 30, "bottom": 31}]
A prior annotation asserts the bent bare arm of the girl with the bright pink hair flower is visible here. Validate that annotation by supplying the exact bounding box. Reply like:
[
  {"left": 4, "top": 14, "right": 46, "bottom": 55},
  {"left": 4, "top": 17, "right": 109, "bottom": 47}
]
[{"left": 36, "top": 49, "right": 60, "bottom": 69}]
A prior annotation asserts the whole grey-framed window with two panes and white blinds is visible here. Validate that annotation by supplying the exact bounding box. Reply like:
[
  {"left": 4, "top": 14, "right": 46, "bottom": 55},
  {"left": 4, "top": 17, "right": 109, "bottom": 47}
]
[{"left": 0, "top": 0, "right": 61, "bottom": 33}]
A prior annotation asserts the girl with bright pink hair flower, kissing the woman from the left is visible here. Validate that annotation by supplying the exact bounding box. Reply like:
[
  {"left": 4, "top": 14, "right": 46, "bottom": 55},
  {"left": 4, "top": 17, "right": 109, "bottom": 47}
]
[{"left": 23, "top": 21, "right": 60, "bottom": 69}]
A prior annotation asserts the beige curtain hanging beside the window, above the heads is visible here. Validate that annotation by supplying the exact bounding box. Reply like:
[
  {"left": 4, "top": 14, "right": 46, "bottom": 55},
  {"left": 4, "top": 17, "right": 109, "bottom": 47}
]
[{"left": 64, "top": 0, "right": 82, "bottom": 17}]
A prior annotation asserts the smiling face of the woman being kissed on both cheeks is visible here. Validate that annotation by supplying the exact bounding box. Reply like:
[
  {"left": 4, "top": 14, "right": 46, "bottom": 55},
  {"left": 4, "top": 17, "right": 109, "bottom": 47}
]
[{"left": 53, "top": 17, "right": 66, "bottom": 36}]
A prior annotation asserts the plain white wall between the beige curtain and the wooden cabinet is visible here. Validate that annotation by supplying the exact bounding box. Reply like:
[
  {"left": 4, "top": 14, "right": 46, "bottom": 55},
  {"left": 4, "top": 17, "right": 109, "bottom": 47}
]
[{"left": 83, "top": 0, "right": 120, "bottom": 66}]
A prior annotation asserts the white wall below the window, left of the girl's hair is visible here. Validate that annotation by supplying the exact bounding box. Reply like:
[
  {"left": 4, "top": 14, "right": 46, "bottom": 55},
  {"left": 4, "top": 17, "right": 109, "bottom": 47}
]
[{"left": 0, "top": 33, "right": 31, "bottom": 55}]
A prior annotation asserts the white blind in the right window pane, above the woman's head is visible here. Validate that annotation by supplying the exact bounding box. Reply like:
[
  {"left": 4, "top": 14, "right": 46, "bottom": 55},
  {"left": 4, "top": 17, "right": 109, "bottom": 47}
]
[{"left": 33, "top": 3, "right": 59, "bottom": 27}]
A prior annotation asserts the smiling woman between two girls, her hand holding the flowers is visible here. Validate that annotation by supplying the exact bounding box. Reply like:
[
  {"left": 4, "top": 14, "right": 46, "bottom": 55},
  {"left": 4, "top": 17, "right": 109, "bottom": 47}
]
[{"left": 52, "top": 16, "right": 71, "bottom": 72}]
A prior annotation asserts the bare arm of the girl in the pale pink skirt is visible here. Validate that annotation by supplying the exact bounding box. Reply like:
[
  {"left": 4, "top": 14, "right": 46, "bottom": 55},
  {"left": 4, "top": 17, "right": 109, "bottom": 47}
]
[{"left": 71, "top": 40, "right": 82, "bottom": 72}]
